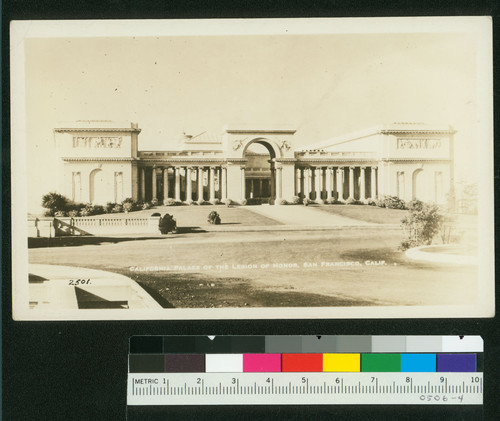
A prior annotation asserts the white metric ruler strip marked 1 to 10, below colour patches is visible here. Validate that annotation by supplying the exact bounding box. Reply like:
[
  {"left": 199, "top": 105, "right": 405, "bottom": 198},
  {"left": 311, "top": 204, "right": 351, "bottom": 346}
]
[{"left": 127, "top": 373, "right": 483, "bottom": 405}]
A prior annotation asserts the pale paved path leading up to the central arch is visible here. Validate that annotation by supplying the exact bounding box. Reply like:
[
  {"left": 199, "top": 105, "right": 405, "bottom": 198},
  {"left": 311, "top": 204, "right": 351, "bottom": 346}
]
[{"left": 246, "top": 205, "right": 378, "bottom": 227}]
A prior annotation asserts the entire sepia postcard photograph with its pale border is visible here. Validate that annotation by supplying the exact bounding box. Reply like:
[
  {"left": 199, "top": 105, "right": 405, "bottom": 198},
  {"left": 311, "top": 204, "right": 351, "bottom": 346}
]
[{"left": 10, "top": 17, "right": 495, "bottom": 320}]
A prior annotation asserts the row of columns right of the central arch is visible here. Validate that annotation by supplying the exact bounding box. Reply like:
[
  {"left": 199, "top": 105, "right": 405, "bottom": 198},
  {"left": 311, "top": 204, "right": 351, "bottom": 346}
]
[{"left": 295, "top": 166, "right": 378, "bottom": 201}]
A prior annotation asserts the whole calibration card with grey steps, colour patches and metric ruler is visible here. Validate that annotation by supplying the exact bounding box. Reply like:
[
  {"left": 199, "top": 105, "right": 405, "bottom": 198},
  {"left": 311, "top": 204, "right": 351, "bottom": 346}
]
[{"left": 128, "top": 336, "right": 483, "bottom": 405}]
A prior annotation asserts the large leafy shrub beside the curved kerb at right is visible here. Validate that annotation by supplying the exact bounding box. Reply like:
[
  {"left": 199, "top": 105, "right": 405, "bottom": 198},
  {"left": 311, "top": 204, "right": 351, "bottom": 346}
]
[{"left": 401, "top": 200, "right": 444, "bottom": 250}]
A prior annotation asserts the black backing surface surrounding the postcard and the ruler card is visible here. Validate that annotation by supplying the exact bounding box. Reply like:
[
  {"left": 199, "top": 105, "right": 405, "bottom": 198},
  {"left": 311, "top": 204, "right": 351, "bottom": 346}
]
[{"left": 2, "top": 0, "right": 500, "bottom": 421}]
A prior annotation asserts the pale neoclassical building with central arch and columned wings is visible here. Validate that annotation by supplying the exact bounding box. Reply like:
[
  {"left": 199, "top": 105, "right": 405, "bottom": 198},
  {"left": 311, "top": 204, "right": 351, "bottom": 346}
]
[{"left": 54, "top": 121, "right": 455, "bottom": 204}]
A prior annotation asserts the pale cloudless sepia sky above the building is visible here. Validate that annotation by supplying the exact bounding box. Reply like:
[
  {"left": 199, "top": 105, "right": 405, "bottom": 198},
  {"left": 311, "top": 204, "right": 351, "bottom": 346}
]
[{"left": 18, "top": 23, "right": 488, "bottom": 207}]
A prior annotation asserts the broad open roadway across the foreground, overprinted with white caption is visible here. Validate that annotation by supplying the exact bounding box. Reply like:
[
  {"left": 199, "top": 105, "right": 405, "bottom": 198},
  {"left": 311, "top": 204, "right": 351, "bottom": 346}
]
[{"left": 29, "top": 226, "right": 477, "bottom": 308}]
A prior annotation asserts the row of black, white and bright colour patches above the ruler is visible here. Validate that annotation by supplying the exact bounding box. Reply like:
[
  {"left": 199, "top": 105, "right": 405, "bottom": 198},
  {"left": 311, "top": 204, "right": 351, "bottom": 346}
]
[{"left": 129, "top": 353, "right": 477, "bottom": 373}]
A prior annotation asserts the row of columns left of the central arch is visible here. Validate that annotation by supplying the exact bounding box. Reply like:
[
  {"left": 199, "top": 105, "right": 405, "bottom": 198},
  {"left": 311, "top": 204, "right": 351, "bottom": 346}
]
[{"left": 140, "top": 166, "right": 227, "bottom": 202}]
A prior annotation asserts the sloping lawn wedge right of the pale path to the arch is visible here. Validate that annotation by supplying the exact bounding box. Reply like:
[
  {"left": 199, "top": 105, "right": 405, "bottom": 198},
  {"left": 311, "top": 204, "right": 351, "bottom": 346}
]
[{"left": 317, "top": 205, "right": 408, "bottom": 224}]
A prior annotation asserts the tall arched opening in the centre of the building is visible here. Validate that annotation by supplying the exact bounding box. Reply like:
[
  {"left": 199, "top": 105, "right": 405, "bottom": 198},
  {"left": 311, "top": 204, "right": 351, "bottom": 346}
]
[{"left": 243, "top": 139, "right": 276, "bottom": 204}]
